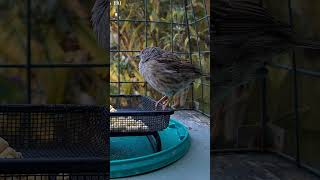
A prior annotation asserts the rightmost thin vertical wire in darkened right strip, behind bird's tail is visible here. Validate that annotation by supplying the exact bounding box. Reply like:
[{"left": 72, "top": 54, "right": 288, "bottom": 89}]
[{"left": 288, "top": 0, "right": 301, "bottom": 166}]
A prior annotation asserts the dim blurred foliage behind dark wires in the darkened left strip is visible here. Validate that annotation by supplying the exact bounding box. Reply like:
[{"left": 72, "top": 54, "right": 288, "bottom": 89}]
[{"left": 0, "top": 0, "right": 109, "bottom": 104}]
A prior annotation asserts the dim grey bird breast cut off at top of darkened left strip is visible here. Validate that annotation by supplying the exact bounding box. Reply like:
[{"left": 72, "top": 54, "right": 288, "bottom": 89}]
[{"left": 91, "top": 0, "right": 109, "bottom": 49}]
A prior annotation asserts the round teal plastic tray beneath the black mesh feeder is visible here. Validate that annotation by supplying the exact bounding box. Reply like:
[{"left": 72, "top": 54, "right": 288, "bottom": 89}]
[{"left": 110, "top": 119, "right": 190, "bottom": 178}]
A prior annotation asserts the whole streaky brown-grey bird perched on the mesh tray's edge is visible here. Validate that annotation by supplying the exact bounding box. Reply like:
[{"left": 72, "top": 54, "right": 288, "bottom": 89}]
[{"left": 136, "top": 47, "right": 202, "bottom": 110}]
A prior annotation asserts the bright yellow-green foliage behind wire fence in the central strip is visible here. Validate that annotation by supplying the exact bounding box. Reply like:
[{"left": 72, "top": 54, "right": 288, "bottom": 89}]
[{"left": 110, "top": 0, "right": 210, "bottom": 115}]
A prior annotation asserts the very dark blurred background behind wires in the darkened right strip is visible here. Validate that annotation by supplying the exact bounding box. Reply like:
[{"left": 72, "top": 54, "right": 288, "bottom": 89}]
[{"left": 217, "top": 0, "right": 320, "bottom": 172}]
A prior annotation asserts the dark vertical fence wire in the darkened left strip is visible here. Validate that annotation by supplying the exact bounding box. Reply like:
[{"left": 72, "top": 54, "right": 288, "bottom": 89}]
[{"left": 27, "top": 0, "right": 32, "bottom": 104}]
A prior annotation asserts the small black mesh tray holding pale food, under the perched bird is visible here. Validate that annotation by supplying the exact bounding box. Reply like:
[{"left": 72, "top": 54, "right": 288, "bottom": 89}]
[{"left": 110, "top": 95, "right": 173, "bottom": 134}]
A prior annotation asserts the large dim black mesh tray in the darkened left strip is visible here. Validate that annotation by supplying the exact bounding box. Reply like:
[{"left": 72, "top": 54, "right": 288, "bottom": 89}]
[{"left": 0, "top": 105, "right": 109, "bottom": 173}]
